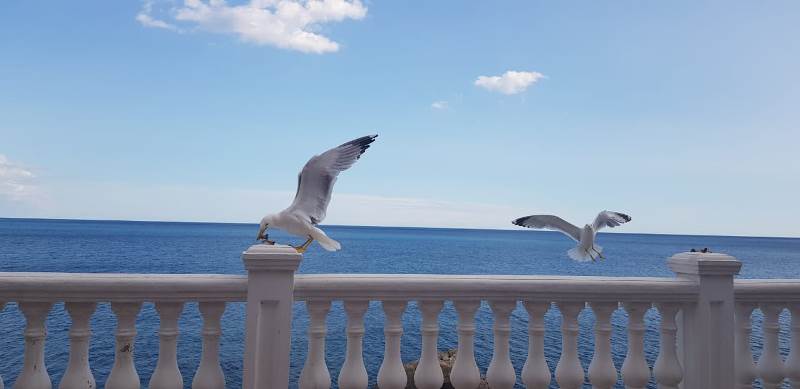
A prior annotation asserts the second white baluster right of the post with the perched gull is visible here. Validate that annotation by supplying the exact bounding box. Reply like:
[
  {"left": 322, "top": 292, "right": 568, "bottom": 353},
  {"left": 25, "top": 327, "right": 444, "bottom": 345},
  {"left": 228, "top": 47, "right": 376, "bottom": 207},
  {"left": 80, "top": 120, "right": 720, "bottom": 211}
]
[{"left": 339, "top": 301, "right": 369, "bottom": 389}]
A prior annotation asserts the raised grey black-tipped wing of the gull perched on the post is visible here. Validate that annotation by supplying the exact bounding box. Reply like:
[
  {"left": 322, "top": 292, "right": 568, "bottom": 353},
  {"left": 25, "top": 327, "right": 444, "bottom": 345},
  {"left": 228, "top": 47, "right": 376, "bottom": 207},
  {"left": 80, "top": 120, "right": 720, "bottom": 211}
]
[{"left": 287, "top": 135, "right": 378, "bottom": 224}]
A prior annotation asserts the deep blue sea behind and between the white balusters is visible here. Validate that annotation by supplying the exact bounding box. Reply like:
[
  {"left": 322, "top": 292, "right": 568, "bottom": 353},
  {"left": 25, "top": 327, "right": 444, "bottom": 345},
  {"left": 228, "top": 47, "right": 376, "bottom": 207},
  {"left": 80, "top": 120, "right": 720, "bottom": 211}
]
[{"left": 0, "top": 218, "right": 800, "bottom": 388}]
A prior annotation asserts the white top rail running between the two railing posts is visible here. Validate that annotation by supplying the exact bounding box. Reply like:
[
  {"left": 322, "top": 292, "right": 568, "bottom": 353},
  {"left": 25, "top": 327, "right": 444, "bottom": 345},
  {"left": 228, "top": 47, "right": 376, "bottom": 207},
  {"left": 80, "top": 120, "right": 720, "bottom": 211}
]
[{"left": 294, "top": 274, "right": 698, "bottom": 302}]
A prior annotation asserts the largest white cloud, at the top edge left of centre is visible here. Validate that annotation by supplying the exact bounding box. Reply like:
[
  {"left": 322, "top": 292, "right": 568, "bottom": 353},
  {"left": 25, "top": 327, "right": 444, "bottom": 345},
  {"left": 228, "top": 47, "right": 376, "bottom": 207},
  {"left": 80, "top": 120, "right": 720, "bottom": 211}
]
[{"left": 136, "top": 0, "right": 367, "bottom": 54}]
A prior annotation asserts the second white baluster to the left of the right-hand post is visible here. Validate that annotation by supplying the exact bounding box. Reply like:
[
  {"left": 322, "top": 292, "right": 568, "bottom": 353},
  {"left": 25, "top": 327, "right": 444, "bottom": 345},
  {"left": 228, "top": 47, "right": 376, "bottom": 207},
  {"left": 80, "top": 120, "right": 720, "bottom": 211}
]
[{"left": 622, "top": 303, "right": 650, "bottom": 389}]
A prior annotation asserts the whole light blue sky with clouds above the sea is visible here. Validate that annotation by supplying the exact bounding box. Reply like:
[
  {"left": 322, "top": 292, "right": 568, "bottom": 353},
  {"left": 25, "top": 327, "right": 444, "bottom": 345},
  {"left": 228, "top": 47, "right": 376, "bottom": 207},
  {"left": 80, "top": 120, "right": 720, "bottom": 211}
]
[{"left": 0, "top": 0, "right": 800, "bottom": 236}]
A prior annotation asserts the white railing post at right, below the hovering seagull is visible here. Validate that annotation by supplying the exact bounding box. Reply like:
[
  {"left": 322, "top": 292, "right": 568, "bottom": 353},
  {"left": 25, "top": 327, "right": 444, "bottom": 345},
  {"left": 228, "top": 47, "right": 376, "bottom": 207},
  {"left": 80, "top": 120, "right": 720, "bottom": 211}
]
[{"left": 667, "top": 252, "right": 742, "bottom": 389}]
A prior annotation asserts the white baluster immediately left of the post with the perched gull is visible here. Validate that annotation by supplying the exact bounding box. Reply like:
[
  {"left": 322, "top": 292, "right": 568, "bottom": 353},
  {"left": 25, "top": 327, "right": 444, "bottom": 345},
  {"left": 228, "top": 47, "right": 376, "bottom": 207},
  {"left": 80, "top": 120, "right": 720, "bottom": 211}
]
[{"left": 192, "top": 301, "right": 225, "bottom": 389}]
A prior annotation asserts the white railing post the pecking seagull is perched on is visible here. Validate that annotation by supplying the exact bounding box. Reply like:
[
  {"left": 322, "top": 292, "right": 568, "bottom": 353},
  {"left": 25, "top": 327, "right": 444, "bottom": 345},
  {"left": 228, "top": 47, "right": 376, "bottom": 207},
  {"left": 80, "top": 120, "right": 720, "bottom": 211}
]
[{"left": 242, "top": 244, "right": 303, "bottom": 389}]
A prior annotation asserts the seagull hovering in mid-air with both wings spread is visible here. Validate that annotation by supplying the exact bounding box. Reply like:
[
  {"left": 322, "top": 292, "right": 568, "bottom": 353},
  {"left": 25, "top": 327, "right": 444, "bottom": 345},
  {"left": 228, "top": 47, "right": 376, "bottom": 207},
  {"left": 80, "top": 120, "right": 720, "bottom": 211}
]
[{"left": 511, "top": 211, "right": 631, "bottom": 262}]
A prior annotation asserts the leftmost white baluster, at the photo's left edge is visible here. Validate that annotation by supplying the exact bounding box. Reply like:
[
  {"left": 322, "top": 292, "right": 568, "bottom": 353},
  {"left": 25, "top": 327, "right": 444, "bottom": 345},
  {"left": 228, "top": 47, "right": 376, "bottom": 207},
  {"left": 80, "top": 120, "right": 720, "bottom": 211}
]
[{"left": 14, "top": 302, "right": 53, "bottom": 389}]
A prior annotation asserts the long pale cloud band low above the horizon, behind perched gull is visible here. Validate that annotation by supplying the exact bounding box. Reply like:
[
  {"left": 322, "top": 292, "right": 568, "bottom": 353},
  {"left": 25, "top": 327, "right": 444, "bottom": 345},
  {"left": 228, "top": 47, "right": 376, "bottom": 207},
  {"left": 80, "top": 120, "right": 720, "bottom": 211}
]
[{"left": 25, "top": 181, "right": 528, "bottom": 228}]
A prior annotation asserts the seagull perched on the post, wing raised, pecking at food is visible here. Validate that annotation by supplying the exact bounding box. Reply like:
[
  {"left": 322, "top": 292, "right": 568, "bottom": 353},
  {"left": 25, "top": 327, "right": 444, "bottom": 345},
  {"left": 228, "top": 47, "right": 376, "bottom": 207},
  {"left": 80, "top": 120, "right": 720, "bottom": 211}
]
[{"left": 256, "top": 135, "right": 378, "bottom": 253}]
